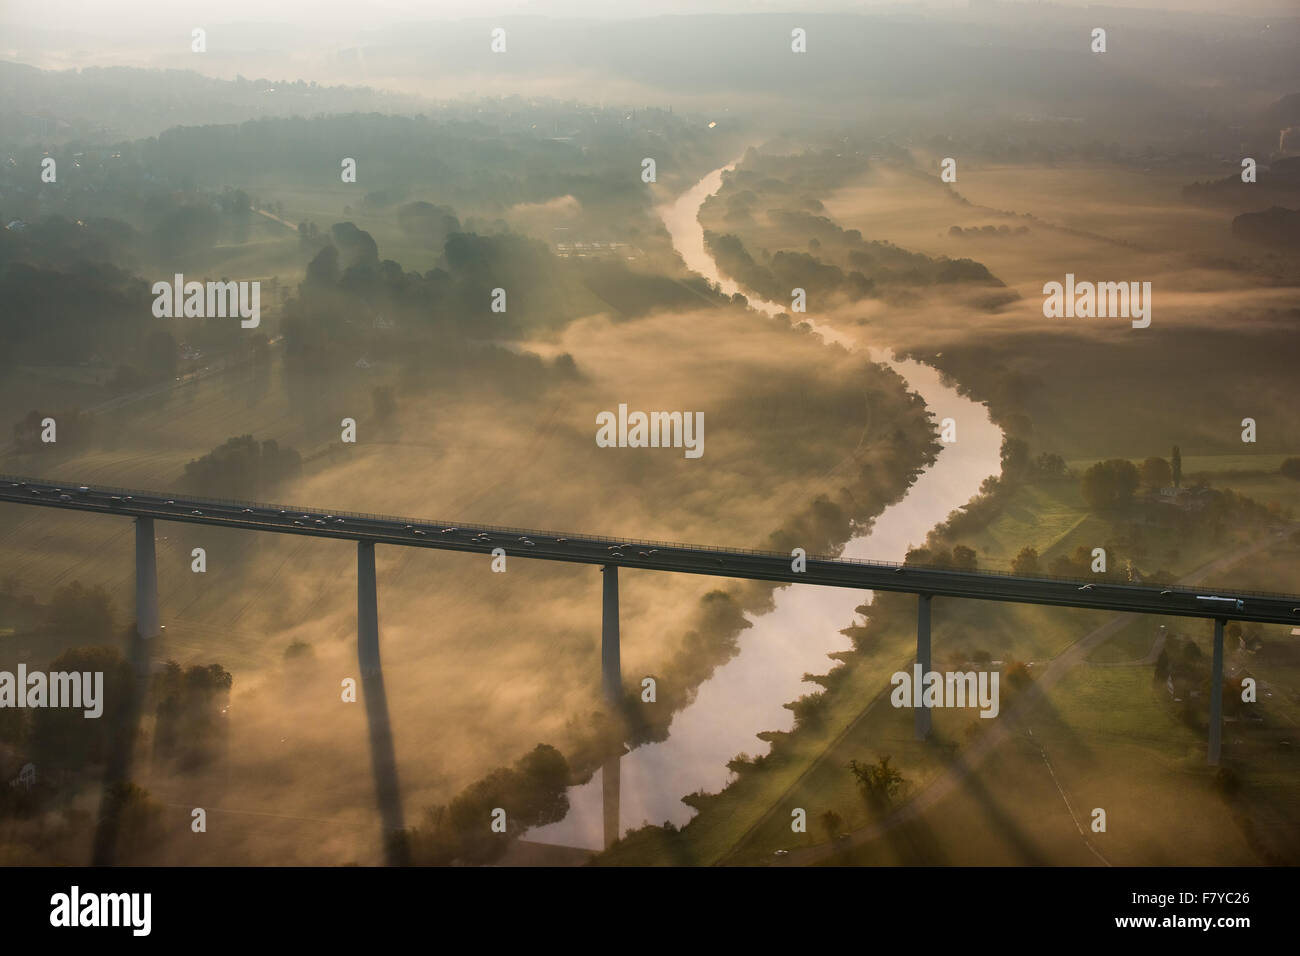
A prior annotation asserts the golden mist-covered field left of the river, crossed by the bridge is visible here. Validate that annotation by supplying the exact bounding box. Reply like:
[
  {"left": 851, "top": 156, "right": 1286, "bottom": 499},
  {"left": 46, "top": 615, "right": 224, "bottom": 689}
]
[{"left": 0, "top": 295, "right": 931, "bottom": 862}]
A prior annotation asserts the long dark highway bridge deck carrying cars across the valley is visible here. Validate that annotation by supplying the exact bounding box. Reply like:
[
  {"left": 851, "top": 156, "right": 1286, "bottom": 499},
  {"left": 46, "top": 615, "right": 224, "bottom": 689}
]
[{"left": 0, "top": 476, "right": 1300, "bottom": 626}]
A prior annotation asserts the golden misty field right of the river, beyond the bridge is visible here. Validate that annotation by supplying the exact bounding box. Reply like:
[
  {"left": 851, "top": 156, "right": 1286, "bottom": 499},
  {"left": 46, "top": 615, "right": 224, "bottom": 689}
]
[{"left": 823, "top": 165, "right": 1300, "bottom": 460}]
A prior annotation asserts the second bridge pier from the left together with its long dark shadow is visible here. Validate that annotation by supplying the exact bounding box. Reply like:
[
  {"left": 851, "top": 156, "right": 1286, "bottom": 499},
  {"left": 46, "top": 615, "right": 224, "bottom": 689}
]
[{"left": 356, "top": 541, "right": 410, "bottom": 866}]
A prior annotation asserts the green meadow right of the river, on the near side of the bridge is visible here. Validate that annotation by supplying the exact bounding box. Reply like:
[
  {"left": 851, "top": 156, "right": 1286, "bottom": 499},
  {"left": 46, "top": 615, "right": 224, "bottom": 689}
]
[{"left": 608, "top": 567, "right": 1300, "bottom": 865}]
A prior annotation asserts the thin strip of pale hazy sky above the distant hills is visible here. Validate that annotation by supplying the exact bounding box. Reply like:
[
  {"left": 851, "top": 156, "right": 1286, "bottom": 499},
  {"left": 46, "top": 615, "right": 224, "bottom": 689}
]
[{"left": 0, "top": 0, "right": 1300, "bottom": 33}]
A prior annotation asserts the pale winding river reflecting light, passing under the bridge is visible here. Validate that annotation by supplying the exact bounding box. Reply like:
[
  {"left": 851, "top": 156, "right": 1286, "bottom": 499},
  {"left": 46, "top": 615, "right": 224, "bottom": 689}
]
[{"left": 525, "top": 164, "right": 1002, "bottom": 849}]
